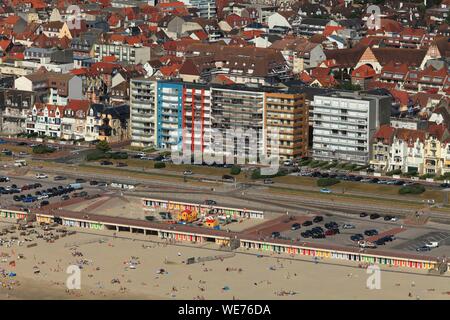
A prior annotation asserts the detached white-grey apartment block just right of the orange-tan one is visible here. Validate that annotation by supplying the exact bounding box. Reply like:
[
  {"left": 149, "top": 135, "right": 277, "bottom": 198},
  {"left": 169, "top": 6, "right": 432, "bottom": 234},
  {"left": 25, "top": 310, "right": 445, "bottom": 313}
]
[{"left": 312, "top": 92, "right": 391, "bottom": 165}]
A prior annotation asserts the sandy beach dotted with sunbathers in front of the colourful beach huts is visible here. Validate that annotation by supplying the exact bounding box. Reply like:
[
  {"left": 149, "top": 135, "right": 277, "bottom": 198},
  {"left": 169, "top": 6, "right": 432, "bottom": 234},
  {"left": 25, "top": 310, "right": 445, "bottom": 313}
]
[{"left": 0, "top": 220, "right": 450, "bottom": 300}]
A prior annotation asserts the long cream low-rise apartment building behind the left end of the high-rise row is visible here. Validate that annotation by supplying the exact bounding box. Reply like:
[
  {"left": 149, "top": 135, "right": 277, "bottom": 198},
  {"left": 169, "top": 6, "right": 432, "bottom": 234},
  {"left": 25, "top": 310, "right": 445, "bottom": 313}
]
[{"left": 94, "top": 42, "right": 151, "bottom": 64}]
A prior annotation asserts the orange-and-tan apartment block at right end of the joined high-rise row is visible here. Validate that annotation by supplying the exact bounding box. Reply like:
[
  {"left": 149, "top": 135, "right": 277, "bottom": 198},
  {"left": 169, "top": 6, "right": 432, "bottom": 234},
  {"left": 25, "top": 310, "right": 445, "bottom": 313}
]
[{"left": 264, "top": 90, "right": 309, "bottom": 160}]
